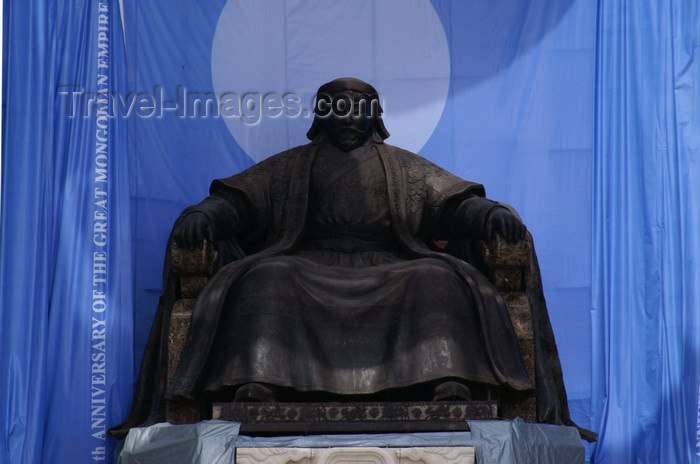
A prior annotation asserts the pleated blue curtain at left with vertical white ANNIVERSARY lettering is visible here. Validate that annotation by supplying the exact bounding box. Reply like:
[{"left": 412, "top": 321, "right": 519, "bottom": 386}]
[{"left": 0, "top": 0, "right": 133, "bottom": 463}]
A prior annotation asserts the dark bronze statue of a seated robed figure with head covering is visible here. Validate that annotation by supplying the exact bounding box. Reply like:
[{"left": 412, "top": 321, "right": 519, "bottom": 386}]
[{"left": 111, "top": 78, "right": 596, "bottom": 436}]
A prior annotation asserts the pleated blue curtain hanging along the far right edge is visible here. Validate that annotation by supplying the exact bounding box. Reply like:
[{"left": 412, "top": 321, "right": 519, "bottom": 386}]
[{"left": 593, "top": 0, "right": 700, "bottom": 464}]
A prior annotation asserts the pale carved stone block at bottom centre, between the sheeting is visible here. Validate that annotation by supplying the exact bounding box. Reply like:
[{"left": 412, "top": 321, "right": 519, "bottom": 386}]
[{"left": 236, "top": 446, "right": 475, "bottom": 464}]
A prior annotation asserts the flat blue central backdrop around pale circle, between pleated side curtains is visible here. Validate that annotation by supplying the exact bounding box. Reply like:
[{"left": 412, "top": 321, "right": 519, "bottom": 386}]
[{"left": 125, "top": 0, "right": 595, "bottom": 438}]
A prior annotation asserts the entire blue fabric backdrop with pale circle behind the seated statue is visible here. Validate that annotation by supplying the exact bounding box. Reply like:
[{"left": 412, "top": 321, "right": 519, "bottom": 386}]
[{"left": 0, "top": 0, "right": 700, "bottom": 463}]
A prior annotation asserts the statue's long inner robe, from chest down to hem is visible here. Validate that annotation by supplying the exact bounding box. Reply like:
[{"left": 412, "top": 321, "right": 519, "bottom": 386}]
[{"left": 185, "top": 143, "right": 532, "bottom": 399}]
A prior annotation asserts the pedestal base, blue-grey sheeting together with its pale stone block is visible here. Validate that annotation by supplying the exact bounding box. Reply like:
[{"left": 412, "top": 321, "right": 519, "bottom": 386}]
[{"left": 117, "top": 419, "right": 585, "bottom": 464}]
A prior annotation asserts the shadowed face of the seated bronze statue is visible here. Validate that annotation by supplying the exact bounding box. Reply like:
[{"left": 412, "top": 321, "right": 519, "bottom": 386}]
[{"left": 326, "top": 91, "right": 372, "bottom": 152}]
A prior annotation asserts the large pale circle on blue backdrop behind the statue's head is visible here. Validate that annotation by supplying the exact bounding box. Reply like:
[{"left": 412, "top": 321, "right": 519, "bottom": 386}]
[{"left": 211, "top": 0, "right": 450, "bottom": 162}]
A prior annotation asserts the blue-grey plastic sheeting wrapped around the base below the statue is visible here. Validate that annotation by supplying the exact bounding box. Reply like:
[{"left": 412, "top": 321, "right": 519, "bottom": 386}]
[{"left": 117, "top": 419, "right": 585, "bottom": 464}]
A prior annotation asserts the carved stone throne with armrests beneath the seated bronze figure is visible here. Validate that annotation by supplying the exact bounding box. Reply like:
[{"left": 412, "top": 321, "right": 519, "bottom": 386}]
[{"left": 165, "top": 217, "right": 540, "bottom": 433}]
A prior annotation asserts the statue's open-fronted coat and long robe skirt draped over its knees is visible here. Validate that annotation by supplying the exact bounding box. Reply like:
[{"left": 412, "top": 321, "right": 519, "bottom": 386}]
[{"left": 168, "top": 137, "right": 532, "bottom": 398}]
